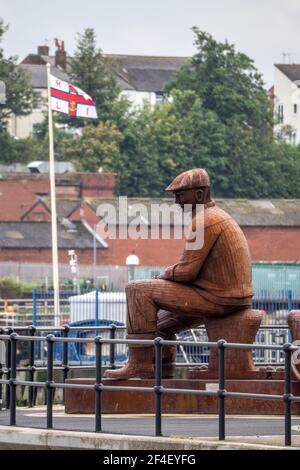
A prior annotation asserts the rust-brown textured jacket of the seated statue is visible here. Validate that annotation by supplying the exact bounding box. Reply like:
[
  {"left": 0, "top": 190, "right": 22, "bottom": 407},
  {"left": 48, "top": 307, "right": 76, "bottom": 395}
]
[{"left": 163, "top": 201, "right": 253, "bottom": 306}]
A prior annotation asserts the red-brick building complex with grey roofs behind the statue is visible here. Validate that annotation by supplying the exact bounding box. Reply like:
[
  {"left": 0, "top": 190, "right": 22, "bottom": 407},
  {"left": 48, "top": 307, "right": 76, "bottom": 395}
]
[{"left": 0, "top": 166, "right": 300, "bottom": 277}]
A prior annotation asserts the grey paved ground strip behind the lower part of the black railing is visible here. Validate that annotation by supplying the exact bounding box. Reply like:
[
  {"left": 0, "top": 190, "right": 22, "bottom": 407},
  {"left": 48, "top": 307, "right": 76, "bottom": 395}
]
[{"left": 0, "top": 406, "right": 300, "bottom": 442}]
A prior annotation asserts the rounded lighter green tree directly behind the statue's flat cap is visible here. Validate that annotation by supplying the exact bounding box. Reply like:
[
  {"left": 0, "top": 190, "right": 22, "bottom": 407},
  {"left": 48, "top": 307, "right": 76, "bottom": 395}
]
[{"left": 118, "top": 90, "right": 225, "bottom": 197}]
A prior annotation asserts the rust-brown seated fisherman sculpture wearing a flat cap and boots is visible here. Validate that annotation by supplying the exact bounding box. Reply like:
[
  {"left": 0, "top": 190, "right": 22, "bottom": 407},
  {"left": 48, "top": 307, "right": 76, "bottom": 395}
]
[{"left": 105, "top": 168, "right": 253, "bottom": 379}]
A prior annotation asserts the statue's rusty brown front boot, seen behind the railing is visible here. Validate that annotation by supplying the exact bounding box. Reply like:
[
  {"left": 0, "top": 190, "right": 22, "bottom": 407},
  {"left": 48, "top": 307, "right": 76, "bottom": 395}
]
[{"left": 104, "top": 345, "right": 154, "bottom": 380}]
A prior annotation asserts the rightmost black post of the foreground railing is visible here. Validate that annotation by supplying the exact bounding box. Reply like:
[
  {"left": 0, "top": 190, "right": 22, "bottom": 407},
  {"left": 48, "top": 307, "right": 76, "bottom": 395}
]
[{"left": 283, "top": 343, "right": 292, "bottom": 446}]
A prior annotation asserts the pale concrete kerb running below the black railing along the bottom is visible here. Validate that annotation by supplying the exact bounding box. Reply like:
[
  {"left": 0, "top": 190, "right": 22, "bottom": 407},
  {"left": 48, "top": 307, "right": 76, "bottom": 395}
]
[{"left": 0, "top": 426, "right": 300, "bottom": 452}]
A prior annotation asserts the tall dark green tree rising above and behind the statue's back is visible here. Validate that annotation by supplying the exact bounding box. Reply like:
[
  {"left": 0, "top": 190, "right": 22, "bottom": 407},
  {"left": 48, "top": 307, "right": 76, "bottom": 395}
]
[{"left": 163, "top": 28, "right": 274, "bottom": 198}]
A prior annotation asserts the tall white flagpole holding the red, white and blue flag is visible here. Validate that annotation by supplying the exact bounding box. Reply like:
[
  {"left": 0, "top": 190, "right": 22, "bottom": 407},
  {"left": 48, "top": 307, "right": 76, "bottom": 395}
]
[{"left": 46, "top": 63, "right": 60, "bottom": 326}]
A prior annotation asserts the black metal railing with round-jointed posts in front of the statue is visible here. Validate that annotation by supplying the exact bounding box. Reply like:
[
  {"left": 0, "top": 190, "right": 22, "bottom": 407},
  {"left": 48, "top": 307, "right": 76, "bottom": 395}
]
[{"left": 0, "top": 328, "right": 300, "bottom": 446}]
